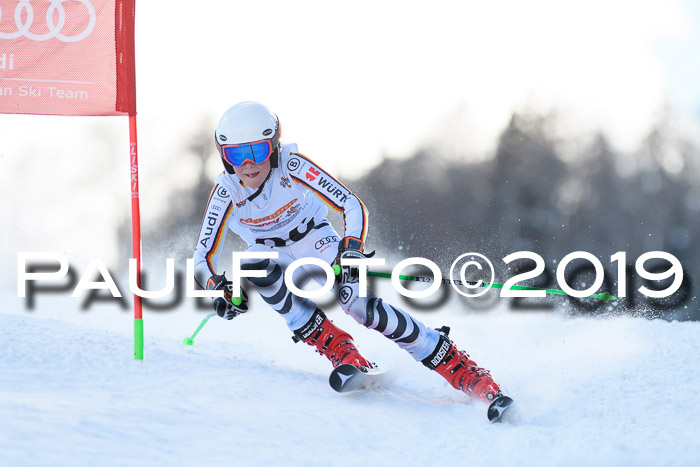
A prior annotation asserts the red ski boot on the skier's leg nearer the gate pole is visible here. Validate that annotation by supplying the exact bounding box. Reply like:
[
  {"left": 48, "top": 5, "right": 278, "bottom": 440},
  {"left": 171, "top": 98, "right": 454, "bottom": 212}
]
[{"left": 294, "top": 308, "right": 374, "bottom": 372}]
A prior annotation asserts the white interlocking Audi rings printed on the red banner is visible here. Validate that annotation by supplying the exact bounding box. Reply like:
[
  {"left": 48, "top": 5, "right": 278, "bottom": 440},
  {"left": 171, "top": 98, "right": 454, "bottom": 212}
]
[{"left": 0, "top": 0, "right": 97, "bottom": 42}]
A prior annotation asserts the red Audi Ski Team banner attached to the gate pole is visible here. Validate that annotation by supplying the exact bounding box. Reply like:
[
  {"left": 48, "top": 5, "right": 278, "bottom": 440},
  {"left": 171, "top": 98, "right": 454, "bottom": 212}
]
[{"left": 0, "top": 0, "right": 136, "bottom": 115}]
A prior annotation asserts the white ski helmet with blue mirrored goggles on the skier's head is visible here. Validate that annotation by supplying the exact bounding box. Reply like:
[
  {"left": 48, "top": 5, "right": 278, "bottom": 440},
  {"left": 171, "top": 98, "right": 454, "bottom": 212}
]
[{"left": 214, "top": 101, "right": 280, "bottom": 174}]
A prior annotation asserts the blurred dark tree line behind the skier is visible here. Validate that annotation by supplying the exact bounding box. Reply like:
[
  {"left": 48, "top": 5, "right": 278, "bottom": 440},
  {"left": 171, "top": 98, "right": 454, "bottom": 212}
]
[{"left": 120, "top": 112, "right": 700, "bottom": 320}]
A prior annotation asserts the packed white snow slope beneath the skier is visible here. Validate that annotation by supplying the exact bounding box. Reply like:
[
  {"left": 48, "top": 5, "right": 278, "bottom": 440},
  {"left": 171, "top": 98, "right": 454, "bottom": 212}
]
[{"left": 0, "top": 290, "right": 700, "bottom": 466}]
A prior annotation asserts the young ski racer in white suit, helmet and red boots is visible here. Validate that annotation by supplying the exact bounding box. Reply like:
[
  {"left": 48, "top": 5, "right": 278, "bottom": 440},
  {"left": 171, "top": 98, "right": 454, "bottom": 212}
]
[{"left": 194, "top": 102, "right": 508, "bottom": 410}]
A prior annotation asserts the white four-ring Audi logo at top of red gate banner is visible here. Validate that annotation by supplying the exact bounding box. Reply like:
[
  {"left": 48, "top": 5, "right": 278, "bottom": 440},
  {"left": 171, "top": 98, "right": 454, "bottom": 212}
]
[{"left": 0, "top": 0, "right": 97, "bottom": 42}]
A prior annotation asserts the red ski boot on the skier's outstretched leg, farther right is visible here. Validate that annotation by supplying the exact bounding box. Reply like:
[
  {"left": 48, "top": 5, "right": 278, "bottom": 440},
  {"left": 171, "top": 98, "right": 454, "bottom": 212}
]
[{"left": 422, "top": 326, "right": 502, "bottom": 401}]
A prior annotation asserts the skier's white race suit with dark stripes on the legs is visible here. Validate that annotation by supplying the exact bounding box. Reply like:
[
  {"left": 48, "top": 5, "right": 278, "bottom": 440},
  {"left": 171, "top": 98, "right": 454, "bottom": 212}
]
[{"left": 194, "top": 144, "right": 440, "bottom": 361}]
